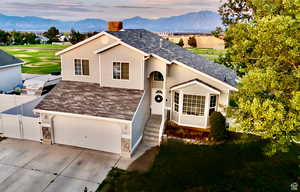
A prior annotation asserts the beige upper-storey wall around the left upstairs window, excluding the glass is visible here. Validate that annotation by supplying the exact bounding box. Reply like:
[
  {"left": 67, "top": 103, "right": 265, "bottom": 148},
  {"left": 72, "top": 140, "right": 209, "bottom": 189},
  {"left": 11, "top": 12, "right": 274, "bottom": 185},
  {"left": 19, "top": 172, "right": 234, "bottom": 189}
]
[{"left": 61, "top": 35, "right": 116, "bottom": 83}]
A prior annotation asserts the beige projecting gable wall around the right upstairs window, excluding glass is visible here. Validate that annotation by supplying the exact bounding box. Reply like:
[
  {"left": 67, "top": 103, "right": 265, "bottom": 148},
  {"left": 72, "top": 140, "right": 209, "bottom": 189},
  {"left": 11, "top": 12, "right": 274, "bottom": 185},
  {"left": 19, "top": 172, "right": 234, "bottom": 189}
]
[{"left": 99, "top": 45, "right": 144, "bottom": 90}]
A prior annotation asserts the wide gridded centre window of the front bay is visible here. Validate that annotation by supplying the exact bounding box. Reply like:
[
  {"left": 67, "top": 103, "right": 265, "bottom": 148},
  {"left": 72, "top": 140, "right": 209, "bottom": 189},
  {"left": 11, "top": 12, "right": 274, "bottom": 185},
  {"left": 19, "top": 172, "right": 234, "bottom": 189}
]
[{"left": 183, "top": 95, "right": 205, "bottom": 116}]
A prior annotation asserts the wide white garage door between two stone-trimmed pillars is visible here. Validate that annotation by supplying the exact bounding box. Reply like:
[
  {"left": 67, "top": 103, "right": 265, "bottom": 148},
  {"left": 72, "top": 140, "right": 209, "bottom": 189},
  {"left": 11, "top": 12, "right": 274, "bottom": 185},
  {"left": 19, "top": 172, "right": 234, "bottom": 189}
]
[{"left": 54, "top": 116, "right": 122, "bottom": 153}]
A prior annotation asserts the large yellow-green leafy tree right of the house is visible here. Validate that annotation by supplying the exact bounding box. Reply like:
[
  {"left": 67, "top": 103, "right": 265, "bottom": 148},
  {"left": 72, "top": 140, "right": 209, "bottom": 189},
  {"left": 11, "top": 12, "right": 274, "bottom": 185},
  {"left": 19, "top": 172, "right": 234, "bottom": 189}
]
[{"left": 225, "top": 0, "right": 300, "bottom": 153}]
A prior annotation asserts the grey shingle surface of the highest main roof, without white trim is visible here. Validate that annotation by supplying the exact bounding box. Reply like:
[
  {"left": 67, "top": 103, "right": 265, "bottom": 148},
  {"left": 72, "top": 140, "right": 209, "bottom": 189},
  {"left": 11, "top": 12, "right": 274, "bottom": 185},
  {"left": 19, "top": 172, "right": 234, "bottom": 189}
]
[{"left": 107, "top": 29, "right": 236, "bottom": 87}]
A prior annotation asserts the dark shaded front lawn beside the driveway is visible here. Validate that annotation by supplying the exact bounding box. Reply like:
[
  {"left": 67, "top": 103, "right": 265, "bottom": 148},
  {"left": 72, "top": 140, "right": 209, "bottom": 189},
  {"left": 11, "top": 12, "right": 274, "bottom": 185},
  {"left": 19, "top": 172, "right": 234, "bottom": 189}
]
[{"left": 98, "top": 134, "right": 300, "bottom": 192}]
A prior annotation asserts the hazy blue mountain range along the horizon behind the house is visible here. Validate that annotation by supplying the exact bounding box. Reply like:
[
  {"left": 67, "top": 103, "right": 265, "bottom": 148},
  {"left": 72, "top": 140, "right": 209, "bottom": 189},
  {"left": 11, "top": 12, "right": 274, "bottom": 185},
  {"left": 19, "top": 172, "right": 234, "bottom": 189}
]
[{"left": 0, "top": 11, "right": 221, "bottom": 33}]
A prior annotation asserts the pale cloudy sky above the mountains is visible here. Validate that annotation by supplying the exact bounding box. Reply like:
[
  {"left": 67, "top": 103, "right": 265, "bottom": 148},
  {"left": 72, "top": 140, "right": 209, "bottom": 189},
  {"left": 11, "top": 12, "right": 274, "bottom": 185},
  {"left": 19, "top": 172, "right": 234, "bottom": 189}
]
[{"left": 0, "top": 0, "right": 220, "bottom": 21}]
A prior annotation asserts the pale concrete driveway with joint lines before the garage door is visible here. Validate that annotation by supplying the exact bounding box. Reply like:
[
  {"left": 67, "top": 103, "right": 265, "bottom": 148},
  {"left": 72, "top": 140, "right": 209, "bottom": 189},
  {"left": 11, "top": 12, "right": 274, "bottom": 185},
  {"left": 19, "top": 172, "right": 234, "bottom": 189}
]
[{"left": 0, "top": 139, "right": 124, "bottom": 192}]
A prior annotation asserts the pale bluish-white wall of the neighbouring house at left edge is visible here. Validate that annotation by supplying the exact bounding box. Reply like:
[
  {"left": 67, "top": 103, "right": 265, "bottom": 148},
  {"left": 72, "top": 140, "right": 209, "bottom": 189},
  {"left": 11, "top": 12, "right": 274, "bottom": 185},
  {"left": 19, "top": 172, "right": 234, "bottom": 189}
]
[{"left": 0, "top": 65, "right": 22, "bottom": 92}]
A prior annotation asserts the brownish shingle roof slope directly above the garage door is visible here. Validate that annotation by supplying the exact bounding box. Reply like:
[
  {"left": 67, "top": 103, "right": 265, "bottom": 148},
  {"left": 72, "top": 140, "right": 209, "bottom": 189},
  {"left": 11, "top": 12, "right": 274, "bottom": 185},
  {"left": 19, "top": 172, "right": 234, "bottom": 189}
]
[{"left": 35, "top": 81, "right": 144, "bottom": 120}]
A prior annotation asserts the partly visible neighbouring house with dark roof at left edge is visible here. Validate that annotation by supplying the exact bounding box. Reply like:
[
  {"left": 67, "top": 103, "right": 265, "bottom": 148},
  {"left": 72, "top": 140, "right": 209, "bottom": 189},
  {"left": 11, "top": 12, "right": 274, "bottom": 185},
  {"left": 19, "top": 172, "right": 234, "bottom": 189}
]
[{"left": 0, "top": 50, "right": 24, "bottom": 93}]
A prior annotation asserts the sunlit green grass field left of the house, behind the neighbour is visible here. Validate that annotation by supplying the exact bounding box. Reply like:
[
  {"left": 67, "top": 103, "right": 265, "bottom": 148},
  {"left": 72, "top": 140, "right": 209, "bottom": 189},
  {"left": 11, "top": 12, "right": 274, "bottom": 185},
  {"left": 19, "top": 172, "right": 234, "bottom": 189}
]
[{"left": 0, "top": 45, "right": 67, "bottom": 74}]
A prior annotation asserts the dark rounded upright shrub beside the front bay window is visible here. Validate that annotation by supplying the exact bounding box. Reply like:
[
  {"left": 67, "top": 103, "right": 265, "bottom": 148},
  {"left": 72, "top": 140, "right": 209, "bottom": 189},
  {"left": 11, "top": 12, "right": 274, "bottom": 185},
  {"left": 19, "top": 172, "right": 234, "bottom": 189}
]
[{"left": 209, "top": 112, "right": 227, "bottom": 141}]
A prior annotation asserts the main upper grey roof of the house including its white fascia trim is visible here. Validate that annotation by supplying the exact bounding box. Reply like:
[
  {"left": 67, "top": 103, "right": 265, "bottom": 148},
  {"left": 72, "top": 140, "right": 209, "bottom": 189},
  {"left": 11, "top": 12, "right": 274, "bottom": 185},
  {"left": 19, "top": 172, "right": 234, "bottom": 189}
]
[{"left": 56, "top": 29, "right": 237, "bottom": 90}]
